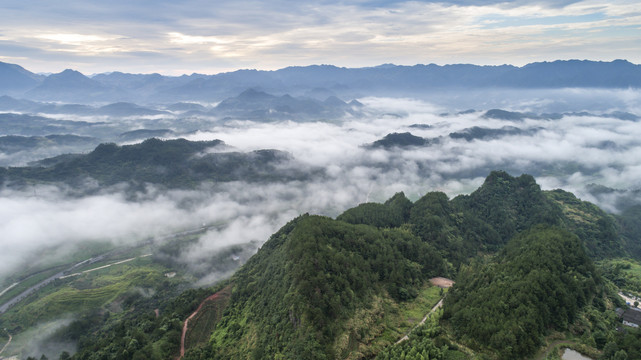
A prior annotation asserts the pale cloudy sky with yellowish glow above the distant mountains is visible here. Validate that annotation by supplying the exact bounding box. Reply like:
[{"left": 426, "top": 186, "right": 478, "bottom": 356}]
[{"left": 0, "top": 0, "right": 641, "bottom": 75}]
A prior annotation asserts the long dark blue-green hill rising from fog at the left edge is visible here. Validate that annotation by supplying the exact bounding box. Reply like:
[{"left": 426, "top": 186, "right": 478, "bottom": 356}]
[{"left": 0, "top": 138, "right": 306, "bottom": 188}]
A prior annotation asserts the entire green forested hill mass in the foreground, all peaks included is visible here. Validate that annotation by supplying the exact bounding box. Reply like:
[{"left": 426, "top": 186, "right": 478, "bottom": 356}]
[{"left": 57, "top": 172, "right": 638, "bottom": 359}]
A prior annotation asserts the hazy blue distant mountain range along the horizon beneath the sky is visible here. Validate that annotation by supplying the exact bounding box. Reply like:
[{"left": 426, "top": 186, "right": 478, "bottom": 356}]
[{"left": 0, "top": 60, "right": 641, "bottom": 104}]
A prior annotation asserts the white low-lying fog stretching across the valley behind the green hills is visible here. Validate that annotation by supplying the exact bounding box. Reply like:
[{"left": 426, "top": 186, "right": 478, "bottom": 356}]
[{"left": 0, "top": 90, "right": 641, "bottom": 283}]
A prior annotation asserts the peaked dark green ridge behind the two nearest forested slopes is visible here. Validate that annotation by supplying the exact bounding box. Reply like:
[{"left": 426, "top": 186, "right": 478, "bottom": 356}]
[{"left": 337, "top": 171, "right": 624, "bottom": 265}]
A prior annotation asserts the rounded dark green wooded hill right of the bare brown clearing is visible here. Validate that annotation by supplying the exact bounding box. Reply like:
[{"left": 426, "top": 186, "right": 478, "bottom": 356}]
[{"left": 444, "top": 226, "right": 604, "bottom": 359}]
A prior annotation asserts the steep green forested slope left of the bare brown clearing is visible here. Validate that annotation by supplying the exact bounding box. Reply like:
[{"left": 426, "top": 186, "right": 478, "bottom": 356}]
[{"left": 195, "top": 215, "right": 445, "bottom": 359}]
